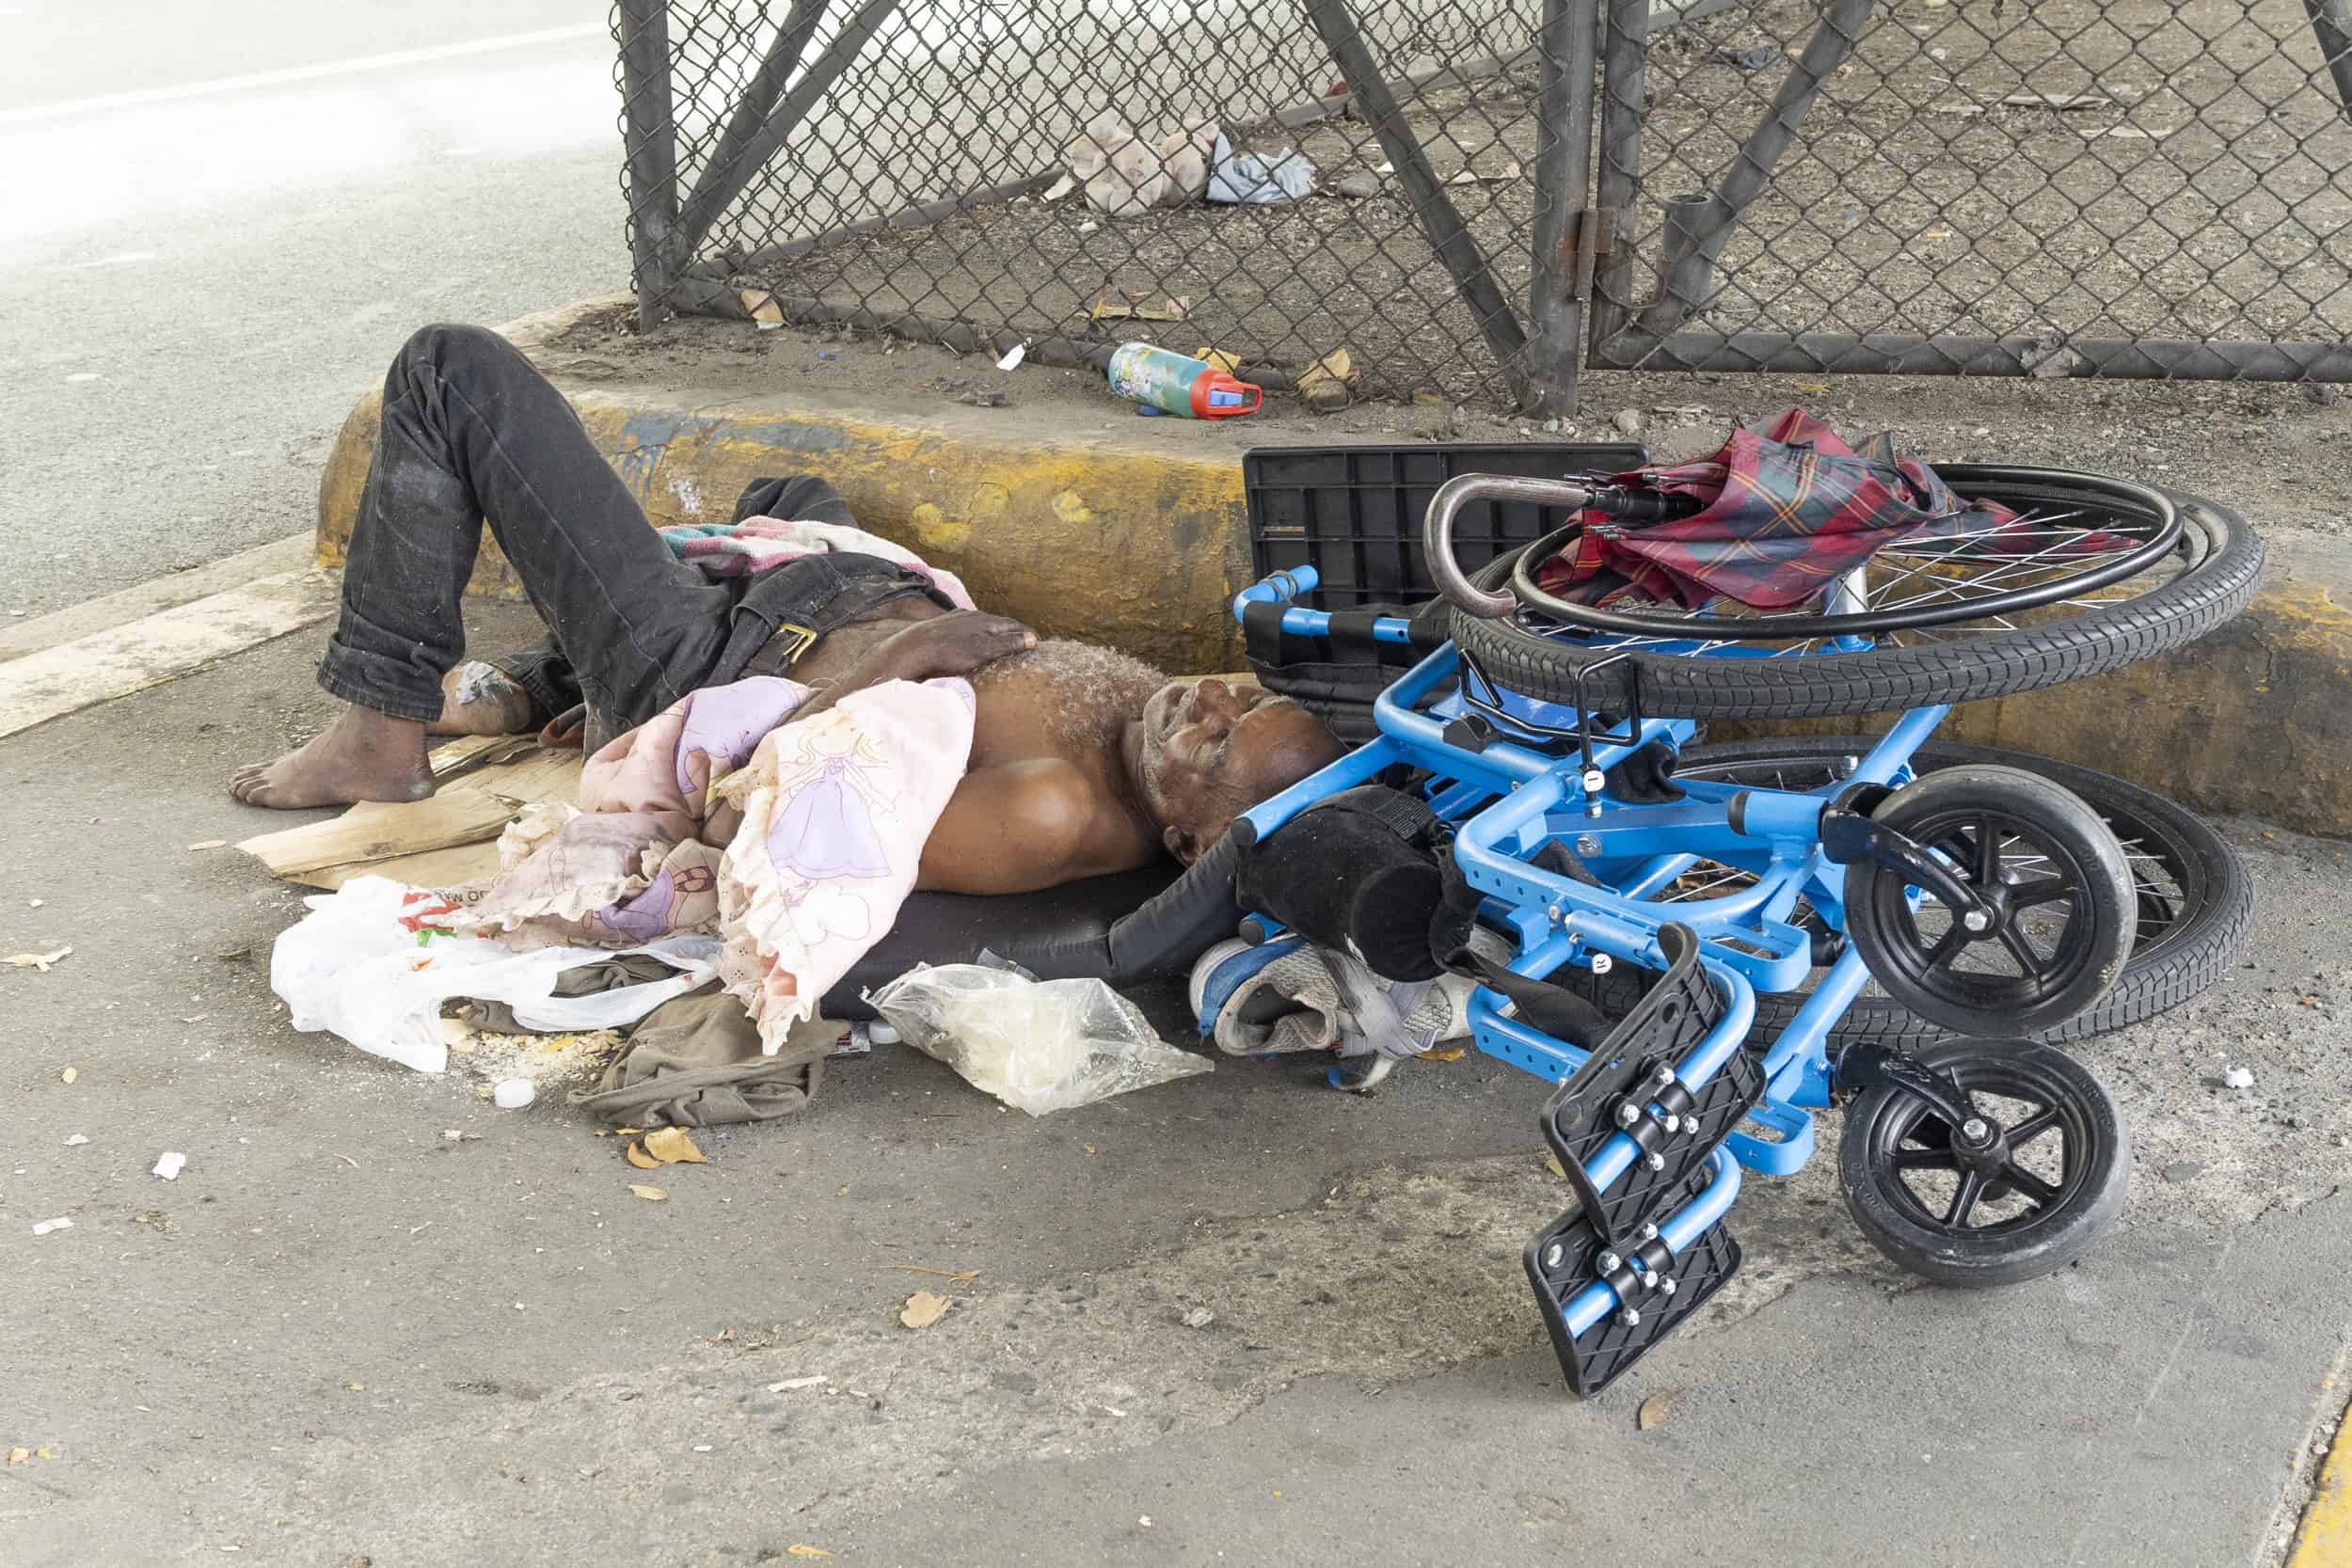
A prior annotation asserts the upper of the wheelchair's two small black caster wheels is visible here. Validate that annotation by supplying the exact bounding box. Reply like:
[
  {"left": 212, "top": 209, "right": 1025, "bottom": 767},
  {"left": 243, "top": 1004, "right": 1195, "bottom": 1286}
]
[{"left": 1847, "top": 764, "right": 2138, "bottom": 1035}]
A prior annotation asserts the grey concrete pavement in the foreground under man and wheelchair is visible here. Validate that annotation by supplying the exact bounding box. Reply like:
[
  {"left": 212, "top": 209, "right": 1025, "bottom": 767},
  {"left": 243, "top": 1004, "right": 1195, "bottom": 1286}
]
[{"left": 0, "top": 602, "right": 2352, "bottom": 1568}]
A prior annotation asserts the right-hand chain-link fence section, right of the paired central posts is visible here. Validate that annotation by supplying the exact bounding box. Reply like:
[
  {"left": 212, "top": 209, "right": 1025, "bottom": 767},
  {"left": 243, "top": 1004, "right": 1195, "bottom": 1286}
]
[{"left": 1593, "top": 0, "right": 2352, "bottom": 381}]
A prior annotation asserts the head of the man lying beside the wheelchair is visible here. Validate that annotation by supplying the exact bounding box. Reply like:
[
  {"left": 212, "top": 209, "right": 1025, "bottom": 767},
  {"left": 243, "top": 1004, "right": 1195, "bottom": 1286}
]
[{"left": 1136, "top": 677, "right": 1345, "bottom": 865}]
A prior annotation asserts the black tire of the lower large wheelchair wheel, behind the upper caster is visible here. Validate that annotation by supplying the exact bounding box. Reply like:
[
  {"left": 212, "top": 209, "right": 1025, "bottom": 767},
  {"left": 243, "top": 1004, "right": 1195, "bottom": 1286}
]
[{"left": 1555, "top": 736, "right": 2253, "bottom": 1051}]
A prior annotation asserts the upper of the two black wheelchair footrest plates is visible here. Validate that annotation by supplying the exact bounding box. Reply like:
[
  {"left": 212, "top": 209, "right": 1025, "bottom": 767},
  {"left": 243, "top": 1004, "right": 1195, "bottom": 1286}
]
[{"left": 1543, "top": 927, "right": 1764, "bottom": 1253}]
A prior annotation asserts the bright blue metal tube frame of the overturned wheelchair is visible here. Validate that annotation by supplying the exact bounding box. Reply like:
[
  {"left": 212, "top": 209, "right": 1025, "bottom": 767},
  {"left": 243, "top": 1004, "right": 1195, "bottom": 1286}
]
[{"left": 1232, "top": 566, "right": 1950, "bottom": 1336}]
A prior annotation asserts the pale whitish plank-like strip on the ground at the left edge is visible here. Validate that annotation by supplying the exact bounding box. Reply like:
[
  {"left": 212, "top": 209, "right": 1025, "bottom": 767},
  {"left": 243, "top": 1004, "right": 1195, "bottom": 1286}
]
[{"left": 0, "top": 566, "right": 337, "bottom": 736}]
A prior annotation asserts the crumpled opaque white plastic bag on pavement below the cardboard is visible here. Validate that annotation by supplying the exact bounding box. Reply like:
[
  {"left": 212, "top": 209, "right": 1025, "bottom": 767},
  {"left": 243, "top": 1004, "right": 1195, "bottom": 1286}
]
[{"left": 271, "top": 877, "right": 720, "bottom": 1072}]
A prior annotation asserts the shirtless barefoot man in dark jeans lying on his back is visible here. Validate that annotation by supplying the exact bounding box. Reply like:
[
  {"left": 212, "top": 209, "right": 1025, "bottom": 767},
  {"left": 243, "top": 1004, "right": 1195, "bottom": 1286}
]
[{"left": 230, "top": 326, "right": 1341, "bottom": 894}]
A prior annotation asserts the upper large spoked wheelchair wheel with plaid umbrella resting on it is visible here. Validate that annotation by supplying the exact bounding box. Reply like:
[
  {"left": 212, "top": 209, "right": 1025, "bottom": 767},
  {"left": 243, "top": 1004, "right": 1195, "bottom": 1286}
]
[{"left": 1452, "top": 474, "right": 2263, "bottom": 720}]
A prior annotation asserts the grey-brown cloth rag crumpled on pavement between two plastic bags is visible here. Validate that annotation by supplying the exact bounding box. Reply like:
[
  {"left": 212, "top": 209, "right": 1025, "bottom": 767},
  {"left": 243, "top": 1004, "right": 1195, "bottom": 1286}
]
[{"left": 564, "top": 991, "right": 842, "bottom": 1126}]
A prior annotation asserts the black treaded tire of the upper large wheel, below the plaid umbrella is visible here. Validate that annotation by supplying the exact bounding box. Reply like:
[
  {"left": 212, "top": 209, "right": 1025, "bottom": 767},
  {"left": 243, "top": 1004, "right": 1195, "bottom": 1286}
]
[{"left": 1452, "top": 482, "right": 2263, "bottom": 720}]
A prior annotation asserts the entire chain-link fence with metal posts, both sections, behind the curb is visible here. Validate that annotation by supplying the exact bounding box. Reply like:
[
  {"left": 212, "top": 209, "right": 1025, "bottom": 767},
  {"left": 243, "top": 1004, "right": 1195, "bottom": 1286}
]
[{"left": 614, "top": 0, "right": 2352, "bottom": 409}]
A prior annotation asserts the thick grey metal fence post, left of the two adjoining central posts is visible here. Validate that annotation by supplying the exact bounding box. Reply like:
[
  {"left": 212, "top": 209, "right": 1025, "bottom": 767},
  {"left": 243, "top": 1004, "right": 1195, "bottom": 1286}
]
[{"left": 1527, "top": 0, "right": 1602, "bottom": 414}]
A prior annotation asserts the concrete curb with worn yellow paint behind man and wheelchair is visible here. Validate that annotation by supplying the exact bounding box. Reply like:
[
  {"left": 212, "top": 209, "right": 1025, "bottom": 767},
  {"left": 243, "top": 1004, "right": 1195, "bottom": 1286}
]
[{"left": 318, "top": 301, "right": 2352, "bottom": 834}]
